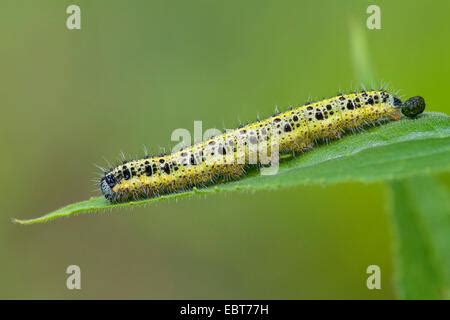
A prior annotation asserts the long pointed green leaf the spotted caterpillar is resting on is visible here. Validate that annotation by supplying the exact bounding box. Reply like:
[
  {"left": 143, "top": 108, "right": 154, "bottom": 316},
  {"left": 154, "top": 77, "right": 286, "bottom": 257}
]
[{"left": 14, "top": 113, "right": 450, "bottom": 224}]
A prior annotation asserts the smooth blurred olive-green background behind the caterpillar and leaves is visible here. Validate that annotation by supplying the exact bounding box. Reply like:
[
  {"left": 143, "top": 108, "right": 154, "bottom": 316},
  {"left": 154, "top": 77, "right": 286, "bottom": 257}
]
[{"left": 0, "top": 0, "right": 450, "bottom": 299}]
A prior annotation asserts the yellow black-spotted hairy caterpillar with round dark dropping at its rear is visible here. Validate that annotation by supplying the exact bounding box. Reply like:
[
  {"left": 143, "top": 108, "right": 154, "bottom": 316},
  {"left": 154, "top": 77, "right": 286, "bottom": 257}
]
[{"left": 99, "top": 90, "right": 425, "bottom": 203}]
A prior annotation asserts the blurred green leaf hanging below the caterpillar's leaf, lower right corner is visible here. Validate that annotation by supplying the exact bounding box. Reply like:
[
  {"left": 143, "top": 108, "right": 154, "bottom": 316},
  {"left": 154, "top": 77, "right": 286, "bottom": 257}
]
[{"left": 391, "top": 177, "right": 450, "bottom": 299}]
